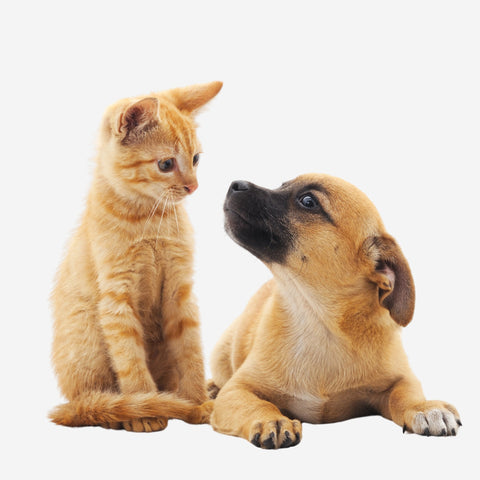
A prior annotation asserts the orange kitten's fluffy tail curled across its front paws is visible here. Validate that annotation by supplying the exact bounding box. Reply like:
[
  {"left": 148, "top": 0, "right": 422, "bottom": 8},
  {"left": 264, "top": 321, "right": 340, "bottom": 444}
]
[{"left": 49, "top": 392, "right": 212, "bottom": 427}]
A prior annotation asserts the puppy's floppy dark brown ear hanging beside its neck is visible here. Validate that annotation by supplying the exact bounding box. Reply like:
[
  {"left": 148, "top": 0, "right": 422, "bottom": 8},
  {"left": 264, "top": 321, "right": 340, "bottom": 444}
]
[{"left": 364, "top": 235, "right": 415, "bottom": 327}]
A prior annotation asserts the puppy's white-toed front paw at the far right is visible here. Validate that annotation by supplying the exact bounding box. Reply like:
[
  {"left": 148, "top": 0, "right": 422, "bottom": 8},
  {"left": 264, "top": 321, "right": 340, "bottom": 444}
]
[{"left": 403, "top": 401, "right": 462, "bottom": 436}]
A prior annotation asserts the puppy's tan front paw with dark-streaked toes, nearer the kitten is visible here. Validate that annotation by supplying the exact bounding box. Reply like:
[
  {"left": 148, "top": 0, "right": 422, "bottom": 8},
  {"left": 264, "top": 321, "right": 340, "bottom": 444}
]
[{"left": 248, "top": 417, "right": 302, "bottom": 449}]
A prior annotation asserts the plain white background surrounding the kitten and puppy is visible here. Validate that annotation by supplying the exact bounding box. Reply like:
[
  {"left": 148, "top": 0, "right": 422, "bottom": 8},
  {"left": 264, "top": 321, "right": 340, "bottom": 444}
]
[{"left": 0, "top": 0, "right": 480, "bottom": 479}]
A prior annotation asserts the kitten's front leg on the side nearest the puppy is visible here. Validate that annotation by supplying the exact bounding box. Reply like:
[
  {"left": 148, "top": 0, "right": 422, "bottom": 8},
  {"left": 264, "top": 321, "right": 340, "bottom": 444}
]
[{"left": 163, "top": 283, "right": 208, "bottom": 404}]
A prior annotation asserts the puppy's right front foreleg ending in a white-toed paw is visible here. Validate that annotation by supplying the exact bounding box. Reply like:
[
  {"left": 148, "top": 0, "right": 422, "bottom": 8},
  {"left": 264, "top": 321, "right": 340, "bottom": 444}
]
[{"left": 380, "top": 378, "right": 462, "bottom": 436}]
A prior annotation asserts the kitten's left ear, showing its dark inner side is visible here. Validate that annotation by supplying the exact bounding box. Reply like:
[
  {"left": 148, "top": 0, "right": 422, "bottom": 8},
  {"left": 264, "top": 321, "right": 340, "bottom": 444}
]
[{"left": 117, "top": 97, "right": 158, "bottom": 139}]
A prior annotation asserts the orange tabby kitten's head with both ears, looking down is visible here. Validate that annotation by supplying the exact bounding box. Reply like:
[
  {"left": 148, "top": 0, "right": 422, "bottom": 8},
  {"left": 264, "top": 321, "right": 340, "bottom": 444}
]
[{"left": 99, "top": 82, "right": 222, "bottom": 202}]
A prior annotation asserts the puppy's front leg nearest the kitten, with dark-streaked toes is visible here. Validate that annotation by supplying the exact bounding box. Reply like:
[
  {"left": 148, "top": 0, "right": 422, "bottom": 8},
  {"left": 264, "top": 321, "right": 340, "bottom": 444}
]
[{"left": 210, "top": 380, "right": 302, "bottom": 448}]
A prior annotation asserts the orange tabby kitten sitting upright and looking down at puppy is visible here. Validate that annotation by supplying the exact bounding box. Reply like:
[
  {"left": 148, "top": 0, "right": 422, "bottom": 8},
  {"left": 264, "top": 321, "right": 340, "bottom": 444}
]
[{"left": 50, "top": 82, "right": 222, "bottom": 431}]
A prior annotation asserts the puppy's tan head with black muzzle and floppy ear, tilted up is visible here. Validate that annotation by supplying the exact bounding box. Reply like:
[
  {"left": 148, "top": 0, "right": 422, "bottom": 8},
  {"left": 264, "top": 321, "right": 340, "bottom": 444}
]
[{"left": 224, "top": 174, "right": 415, "bottom": 326}]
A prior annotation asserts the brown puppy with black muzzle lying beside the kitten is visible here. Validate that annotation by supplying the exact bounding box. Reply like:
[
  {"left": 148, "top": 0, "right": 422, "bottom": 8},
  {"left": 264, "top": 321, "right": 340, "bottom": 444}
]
[{"left": 211, "top": 175, "right": 461, "bottom": 448}]
